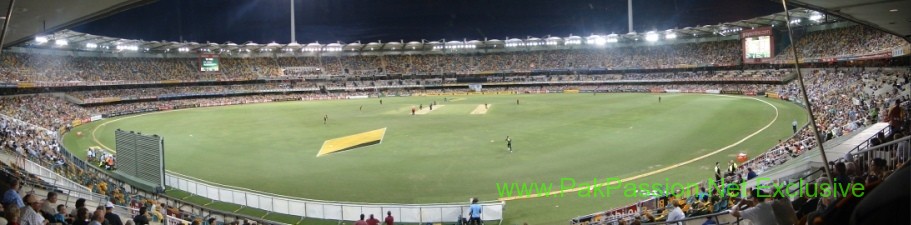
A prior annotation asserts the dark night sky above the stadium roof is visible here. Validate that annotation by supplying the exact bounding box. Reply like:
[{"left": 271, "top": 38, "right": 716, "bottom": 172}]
[{"left": 72, "top": 0, "right": 783, "bottom": 44}]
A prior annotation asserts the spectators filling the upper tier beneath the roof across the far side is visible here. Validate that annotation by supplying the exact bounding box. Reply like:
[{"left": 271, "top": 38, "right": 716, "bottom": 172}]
[{"left": 0, "top": 25, "right": 909, "bottom": 82}]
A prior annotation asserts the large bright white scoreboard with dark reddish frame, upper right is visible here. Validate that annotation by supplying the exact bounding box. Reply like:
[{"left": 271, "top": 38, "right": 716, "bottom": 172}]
[{"left": 740, "top": 27, "right": 775, "bottom": 63}]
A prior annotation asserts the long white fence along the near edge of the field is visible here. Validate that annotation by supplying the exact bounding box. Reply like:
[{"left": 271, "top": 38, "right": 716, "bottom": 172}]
[{"left": 165, "top": 172, "right": 506, "bottom": 223}]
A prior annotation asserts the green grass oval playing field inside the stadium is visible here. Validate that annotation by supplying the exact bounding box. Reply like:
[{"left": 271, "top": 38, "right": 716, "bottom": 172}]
[{"left": 64, "top": 94, "right": 806, "bottom": 224}]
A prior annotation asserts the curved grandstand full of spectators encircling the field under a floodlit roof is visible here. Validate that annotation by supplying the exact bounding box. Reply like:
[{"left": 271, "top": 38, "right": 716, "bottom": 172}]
[{"left": 0, "top": 0, "right": 911, "bottom": 225}]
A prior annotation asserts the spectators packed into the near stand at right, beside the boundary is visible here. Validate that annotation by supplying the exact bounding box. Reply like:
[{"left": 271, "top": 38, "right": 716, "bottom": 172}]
[{"left": 588, "top": 69, "right": 911, "bottom": 225}]
